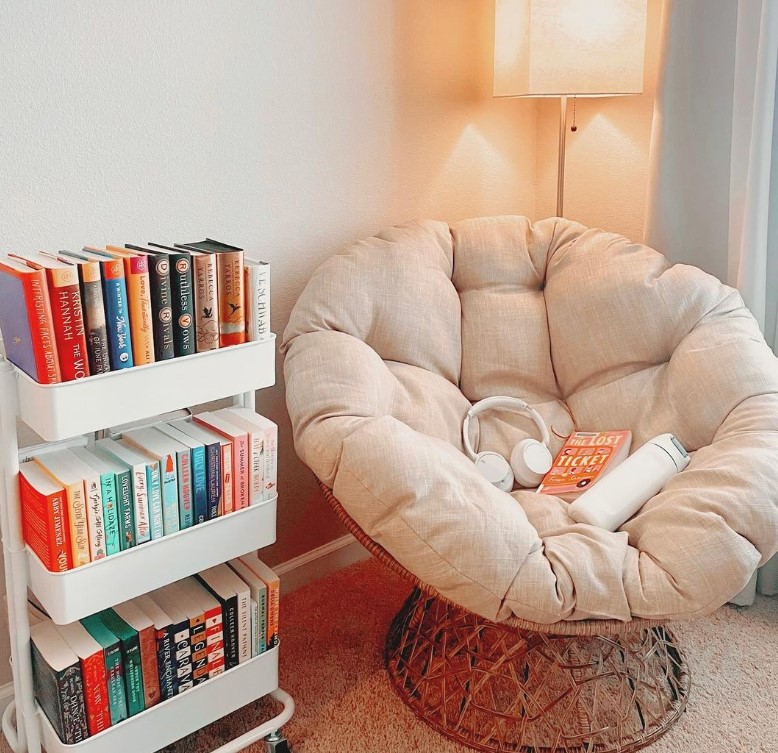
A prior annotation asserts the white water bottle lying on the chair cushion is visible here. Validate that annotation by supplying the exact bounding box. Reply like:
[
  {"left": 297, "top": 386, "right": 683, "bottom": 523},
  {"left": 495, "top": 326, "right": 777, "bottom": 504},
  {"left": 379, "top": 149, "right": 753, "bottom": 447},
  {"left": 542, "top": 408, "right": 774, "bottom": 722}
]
[{"left": 568, "top": 434, "right": 689, "bottom": 531}]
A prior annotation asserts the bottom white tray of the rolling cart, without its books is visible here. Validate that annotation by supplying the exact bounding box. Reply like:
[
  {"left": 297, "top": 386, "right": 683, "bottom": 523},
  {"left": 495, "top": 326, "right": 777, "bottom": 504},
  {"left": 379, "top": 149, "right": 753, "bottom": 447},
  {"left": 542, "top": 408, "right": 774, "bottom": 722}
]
[{"left": 38, "top": 646, "right": 278, "bottom": 753}]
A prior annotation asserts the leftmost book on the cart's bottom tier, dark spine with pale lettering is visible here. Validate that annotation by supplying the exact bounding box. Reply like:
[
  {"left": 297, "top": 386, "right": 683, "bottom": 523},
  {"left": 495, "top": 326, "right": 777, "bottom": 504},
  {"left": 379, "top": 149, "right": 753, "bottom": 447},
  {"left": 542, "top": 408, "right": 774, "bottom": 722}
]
[{"left": 30, "top": 622, "right": 89, "bottom": 745}]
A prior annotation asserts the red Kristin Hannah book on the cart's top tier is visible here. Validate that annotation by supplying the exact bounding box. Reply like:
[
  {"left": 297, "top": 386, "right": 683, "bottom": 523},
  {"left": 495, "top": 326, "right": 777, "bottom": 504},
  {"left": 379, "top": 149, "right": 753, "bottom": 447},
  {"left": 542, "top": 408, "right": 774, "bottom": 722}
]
[{"left": 13, "top": 254, "right": 89, "bottom": 382}]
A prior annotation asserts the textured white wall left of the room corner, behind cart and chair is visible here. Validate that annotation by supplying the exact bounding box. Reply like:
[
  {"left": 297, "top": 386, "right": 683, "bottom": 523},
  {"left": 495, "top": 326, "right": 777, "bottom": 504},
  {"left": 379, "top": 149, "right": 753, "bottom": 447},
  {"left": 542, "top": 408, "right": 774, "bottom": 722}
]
[{"left": 0, "top": 0, "right": 535, "bottom": 682}]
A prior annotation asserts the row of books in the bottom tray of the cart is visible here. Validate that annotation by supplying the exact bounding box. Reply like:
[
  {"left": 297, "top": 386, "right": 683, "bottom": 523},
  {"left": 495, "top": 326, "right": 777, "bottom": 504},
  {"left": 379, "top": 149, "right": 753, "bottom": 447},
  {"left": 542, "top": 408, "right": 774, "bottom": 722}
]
[{"left": 30, "top": 553, "right": 279, "bottom": 745}]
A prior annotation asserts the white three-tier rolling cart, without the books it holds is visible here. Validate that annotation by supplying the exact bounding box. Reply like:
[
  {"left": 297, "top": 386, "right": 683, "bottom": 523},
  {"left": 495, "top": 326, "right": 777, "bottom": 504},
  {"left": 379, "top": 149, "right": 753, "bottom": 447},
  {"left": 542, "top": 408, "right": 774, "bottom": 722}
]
[{"left": 0, "top": 336, "right": 294, "bottom": 753}]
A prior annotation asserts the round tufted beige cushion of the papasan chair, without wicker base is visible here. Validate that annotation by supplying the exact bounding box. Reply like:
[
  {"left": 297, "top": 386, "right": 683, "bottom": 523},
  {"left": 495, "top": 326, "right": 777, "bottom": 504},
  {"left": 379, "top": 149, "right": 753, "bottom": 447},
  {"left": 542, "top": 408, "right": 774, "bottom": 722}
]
[{"left": 282, "top": 217, "right": 778, "bottom": 623}]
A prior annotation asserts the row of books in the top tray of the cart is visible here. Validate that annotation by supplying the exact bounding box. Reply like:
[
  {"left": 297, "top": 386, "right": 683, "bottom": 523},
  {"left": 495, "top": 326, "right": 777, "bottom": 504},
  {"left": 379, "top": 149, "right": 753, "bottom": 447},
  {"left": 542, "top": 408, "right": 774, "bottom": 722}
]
[{"left": 0, "top": 239, "right": 270, "bottom": 384}]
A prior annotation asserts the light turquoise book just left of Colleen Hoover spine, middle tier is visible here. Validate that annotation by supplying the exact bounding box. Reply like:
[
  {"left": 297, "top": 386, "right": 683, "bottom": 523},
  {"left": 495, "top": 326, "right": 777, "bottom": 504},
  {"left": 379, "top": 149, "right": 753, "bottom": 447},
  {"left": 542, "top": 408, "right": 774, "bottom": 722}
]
[{"left": 123, "top": 426, "right": 182, "bottom": 536}]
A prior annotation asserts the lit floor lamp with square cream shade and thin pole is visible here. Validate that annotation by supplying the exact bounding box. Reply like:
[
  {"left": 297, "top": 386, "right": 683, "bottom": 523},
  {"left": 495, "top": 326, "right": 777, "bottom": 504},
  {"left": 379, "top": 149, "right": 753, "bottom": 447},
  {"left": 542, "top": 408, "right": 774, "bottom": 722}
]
[{"left": 494, "top": 0, "right": 647, "bottom": 216}]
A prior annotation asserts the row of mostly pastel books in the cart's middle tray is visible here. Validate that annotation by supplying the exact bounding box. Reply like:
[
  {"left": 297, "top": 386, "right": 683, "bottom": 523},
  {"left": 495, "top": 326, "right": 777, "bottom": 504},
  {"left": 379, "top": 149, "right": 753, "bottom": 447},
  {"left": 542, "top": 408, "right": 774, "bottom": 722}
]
[{"left": 19, "top": 406, "right": 278, "bottom": 572}]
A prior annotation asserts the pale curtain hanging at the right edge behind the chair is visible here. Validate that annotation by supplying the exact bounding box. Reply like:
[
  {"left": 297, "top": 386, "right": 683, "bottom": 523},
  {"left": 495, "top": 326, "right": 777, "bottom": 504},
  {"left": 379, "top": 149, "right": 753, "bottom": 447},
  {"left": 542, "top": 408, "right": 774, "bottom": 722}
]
[{"left": 645, "top": 0, "right": 778, "bottom": 603}]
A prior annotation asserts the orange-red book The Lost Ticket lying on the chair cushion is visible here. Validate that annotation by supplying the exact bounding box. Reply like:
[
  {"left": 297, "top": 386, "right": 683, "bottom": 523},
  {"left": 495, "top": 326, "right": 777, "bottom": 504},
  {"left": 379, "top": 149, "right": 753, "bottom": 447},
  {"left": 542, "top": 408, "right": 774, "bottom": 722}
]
[{"left": 537, "top": 431, "right": 632, "bottom": 497}]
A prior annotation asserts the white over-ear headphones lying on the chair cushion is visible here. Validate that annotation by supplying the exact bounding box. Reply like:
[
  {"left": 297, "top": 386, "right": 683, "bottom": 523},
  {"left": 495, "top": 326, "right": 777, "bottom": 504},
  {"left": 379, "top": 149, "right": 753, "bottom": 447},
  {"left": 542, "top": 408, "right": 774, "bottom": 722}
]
[{"left": 462, "top": 395, "right": 553, "bottom": 492}]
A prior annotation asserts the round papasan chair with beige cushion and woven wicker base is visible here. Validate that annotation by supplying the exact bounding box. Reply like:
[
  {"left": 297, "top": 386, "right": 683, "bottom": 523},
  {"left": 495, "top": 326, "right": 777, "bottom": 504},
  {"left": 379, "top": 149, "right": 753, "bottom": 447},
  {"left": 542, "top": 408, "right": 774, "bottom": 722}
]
[{"left": 282, "top": 216, "right": 778, "bottom": 753}]
